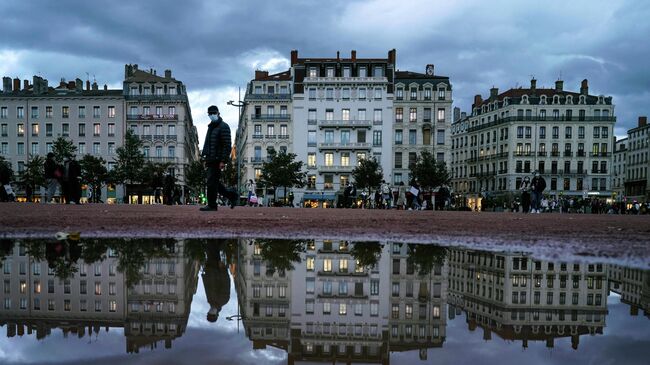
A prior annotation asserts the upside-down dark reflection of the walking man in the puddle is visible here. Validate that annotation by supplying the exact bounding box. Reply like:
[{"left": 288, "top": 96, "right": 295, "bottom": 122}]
[{"left": 202, "top": 240, "right": 230, "bottom": 323}]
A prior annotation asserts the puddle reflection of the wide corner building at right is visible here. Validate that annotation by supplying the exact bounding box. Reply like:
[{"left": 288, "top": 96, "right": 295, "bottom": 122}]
[{"left": 449, "top": 249, "right": 607, "bottom": 349}]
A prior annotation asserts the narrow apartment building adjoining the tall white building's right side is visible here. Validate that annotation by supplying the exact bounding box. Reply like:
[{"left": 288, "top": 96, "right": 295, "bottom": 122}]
[{"left": 392, "top": 64, "right": 452, "bottom": 185}]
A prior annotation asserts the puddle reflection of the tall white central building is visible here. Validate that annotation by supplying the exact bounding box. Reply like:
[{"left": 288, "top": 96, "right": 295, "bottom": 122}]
[{"left": 289, "top": 240, "right": 390, "bottom": 364}]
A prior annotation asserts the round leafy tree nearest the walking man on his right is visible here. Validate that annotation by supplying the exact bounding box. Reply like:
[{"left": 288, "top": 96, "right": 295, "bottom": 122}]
[{"left": 261, "top": 150, "right": 307, "bottom": 203}]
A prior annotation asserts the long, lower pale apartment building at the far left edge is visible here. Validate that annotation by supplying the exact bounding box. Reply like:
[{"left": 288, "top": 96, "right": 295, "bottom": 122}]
[{"left": 0, "top": 76, "right": 125, "bottom": 202}]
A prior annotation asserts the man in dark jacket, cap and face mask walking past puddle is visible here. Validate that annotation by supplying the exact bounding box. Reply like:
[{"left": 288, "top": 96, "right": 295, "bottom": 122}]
[{"left": 200, "top": 105, "right": 238, "bottom": 211}]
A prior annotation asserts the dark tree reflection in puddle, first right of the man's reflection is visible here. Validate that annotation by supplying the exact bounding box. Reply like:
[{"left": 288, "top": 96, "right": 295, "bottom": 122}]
[{"left": 255, "top": 239, "right": 306, "bottom": 275}]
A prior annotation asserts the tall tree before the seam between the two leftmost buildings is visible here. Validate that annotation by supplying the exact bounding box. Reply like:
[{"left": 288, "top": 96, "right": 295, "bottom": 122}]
[{"left": 112, "top": 129, "right": 144, "bottom": 197}]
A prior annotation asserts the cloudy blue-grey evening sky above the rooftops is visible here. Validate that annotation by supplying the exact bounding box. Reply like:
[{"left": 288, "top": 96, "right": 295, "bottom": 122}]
[{"left": 0, "top": 0, "right": 650, "bottom": 144}]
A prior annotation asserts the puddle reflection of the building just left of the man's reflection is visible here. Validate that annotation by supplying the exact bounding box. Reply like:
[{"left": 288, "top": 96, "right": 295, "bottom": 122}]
[{"left": 124, "top": 241, "right": 199, "bottom": 352}]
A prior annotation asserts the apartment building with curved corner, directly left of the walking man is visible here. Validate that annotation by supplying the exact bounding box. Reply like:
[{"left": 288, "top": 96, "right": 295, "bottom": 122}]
[{"left": 123, "top": 64, "right": 199, "bottom": 204}]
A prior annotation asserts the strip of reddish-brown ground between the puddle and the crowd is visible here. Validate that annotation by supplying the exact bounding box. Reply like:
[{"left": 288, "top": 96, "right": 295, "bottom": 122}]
[{"left": 0, "top": 203, "right": 650, "bottom": 268}]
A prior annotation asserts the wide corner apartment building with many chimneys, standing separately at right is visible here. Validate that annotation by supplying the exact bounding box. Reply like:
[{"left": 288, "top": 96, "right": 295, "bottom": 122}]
[{"left": 451, "top": 79, "right": 616, "bottom": 206}]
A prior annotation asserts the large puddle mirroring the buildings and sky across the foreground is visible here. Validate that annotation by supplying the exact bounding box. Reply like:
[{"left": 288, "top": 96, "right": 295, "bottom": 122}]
[{"left": 0, "top": 237, "right": 650, "bottom": 364}]
